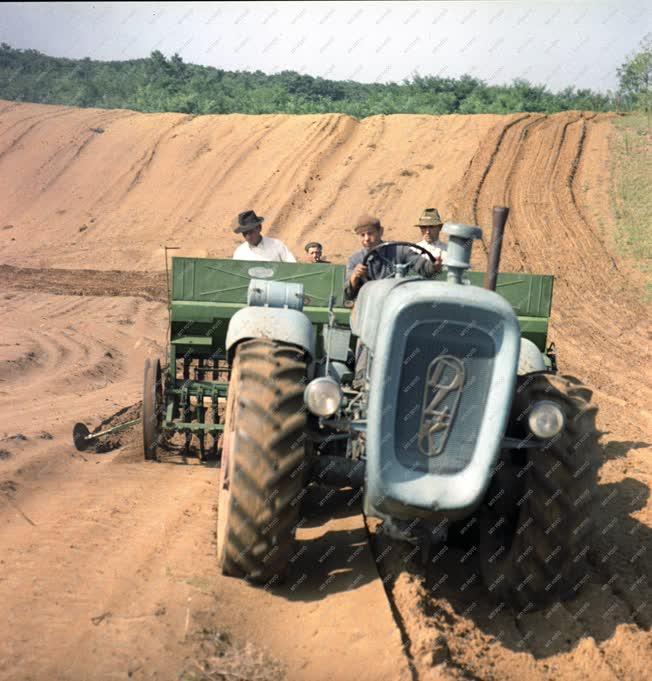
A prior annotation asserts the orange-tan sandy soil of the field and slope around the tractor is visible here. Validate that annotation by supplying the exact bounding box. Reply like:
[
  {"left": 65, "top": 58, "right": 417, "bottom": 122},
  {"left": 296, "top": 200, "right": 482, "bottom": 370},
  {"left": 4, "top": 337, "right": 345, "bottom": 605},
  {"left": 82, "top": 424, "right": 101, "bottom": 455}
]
[{"left": 0, "top": 102, "right": 652, "bottom": 681}]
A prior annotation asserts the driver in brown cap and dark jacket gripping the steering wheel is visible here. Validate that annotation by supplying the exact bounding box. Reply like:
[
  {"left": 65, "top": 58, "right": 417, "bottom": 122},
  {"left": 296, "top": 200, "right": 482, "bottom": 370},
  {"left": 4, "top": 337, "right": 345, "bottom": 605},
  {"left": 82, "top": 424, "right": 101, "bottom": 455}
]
[{"left": 344, "top": 215, "right": 441, "bottom": 299}]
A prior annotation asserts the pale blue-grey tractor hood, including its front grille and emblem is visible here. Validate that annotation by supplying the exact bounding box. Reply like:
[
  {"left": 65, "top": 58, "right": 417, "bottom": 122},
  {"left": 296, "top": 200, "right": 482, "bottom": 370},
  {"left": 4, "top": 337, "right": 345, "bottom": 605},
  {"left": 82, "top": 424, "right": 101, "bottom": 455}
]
[{"left": 356, "top": 279, "right": 520, "bottom": 519}]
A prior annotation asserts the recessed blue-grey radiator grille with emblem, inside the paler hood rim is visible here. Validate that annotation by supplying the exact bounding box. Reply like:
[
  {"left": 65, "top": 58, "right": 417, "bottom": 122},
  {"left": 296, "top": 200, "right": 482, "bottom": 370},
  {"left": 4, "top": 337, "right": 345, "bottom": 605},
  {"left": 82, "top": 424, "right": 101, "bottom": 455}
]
[{"left": 394, "top": 320, "right": 495, "bottom": 475}]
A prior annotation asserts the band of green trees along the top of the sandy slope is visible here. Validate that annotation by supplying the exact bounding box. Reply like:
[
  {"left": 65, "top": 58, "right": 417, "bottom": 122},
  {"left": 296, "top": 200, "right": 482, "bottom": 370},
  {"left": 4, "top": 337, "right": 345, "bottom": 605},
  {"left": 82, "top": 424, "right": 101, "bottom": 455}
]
[{"left": 0, "top": 40, "right": 650, "bottom": 118}]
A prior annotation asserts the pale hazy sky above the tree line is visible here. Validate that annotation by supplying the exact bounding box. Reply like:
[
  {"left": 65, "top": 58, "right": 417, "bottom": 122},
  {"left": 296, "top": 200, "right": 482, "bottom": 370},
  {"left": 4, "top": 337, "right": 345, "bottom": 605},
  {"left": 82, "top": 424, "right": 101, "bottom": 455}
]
[{"left": 0, "top": 0, "right": 652, "bottom": 92}]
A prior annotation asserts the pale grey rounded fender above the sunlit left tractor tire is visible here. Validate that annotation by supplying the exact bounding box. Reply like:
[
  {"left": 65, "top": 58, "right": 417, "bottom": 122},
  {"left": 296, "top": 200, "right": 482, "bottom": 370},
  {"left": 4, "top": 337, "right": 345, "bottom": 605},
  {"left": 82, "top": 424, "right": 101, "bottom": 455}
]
[{"left": 226, "top": 307, "right": 315, "bottom": 361}]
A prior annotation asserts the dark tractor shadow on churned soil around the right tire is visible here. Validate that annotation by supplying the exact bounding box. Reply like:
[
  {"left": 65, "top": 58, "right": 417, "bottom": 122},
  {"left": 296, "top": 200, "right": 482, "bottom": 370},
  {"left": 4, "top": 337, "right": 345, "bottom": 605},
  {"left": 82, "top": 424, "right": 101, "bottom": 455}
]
[{"left": 374, "top": 464, "right": 652, "bottom": 659}]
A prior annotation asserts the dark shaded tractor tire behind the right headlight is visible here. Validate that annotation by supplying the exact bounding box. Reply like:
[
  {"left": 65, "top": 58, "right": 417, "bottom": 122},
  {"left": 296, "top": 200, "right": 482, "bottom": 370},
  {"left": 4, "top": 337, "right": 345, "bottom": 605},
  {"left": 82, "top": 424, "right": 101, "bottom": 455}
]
[{"left": 480, "top": 374, "right": 598, "bottom": 611}]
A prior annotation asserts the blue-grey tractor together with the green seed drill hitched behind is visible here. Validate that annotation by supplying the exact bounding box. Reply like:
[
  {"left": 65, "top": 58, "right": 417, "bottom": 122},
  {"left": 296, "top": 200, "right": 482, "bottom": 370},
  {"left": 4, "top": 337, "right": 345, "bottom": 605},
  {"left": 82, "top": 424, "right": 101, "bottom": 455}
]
[{"left": 142, "top": 208, "right": 597, "bottom": 609}]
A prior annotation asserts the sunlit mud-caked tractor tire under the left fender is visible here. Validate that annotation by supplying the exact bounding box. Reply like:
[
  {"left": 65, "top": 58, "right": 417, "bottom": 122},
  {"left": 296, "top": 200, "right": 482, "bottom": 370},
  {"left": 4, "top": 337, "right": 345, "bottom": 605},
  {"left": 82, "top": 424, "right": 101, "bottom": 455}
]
[{"left": 217, "top": 339, "right": 306, "bottom": 584}]
